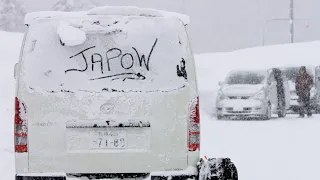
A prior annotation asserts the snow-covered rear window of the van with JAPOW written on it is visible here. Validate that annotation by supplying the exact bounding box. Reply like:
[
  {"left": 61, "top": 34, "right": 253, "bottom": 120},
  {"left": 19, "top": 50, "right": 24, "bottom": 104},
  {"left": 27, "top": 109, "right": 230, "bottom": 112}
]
[{"left": 22, "top": 16, "right": 192, "bottom": 92}]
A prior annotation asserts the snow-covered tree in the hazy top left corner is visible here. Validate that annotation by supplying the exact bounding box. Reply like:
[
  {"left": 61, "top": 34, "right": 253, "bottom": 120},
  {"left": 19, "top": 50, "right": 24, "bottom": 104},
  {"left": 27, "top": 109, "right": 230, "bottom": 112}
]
[{"left": 0, "top": 0, "right": 26, "bottom": 32}]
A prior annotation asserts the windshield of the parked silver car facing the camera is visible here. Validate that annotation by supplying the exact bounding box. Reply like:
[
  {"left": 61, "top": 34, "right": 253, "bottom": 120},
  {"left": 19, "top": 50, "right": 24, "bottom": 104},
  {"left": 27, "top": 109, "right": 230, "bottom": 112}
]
[{"left": 225, "top": 71, "right": 266, "bottom": 85}]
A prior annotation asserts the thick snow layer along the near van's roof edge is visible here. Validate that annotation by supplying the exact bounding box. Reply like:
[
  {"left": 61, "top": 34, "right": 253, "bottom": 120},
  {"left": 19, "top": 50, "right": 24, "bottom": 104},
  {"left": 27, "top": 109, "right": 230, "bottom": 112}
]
[{"left": 25, "top": 6, "right": 190, "bottom": 25}]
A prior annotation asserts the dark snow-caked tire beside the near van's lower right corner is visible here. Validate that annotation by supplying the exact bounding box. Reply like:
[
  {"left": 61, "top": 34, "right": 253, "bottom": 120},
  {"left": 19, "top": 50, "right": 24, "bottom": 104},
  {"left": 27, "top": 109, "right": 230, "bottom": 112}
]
[{"left": 198, "top": 158, "right": 238, "bottom": 180}]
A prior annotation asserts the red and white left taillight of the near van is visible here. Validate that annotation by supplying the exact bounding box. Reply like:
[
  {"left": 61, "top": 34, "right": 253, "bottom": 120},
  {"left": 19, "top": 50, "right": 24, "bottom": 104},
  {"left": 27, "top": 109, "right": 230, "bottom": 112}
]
[{"left": 14, "top": 97, "right": 28, "bottom": 153}]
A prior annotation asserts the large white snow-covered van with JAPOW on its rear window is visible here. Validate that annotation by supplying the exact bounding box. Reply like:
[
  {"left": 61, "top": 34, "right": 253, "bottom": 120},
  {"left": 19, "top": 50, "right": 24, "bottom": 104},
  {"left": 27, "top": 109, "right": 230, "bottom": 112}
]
[{"left": 14, "top": 7, "right": 235, "bottom": 180}]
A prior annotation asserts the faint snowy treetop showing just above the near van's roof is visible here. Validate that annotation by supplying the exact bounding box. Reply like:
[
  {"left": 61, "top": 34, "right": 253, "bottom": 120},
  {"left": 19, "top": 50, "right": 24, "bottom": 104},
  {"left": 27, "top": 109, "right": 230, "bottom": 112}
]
[{"left": 53, "top": 0, "right": 96, "bottom": 12}]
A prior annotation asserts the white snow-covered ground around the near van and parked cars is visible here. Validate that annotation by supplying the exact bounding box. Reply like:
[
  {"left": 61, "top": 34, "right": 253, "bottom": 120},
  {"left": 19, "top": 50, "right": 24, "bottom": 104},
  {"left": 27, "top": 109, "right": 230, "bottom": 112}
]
[{"left": 0, "top": 31, "right": 320, "bottom": 180}]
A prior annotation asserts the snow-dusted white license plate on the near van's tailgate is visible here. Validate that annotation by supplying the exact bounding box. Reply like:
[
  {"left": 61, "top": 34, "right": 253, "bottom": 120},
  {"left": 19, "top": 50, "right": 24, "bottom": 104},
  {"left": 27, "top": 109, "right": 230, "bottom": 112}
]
[{"left": 90, "top": 130, "right": 128, "bottom": 149}]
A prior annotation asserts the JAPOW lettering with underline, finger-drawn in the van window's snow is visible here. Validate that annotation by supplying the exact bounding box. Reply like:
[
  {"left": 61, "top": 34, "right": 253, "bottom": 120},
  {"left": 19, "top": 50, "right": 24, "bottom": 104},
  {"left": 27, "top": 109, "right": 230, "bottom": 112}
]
[{"left": 65, "top": 39, "right": 158, "bottom": 81}]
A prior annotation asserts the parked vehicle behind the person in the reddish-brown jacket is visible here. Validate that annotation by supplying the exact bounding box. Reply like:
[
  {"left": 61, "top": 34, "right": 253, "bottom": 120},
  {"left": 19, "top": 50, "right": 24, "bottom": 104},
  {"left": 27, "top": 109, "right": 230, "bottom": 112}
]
[{"left": 280, "top": 66, "right": 320, "bottom": 113}]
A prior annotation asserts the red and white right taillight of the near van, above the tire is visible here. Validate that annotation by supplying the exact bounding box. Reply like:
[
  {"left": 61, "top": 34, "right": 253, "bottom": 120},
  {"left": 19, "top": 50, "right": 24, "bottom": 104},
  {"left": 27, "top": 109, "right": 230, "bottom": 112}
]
[{"left": 188, "top": 97, "right": 200, "bottom": 151}]
